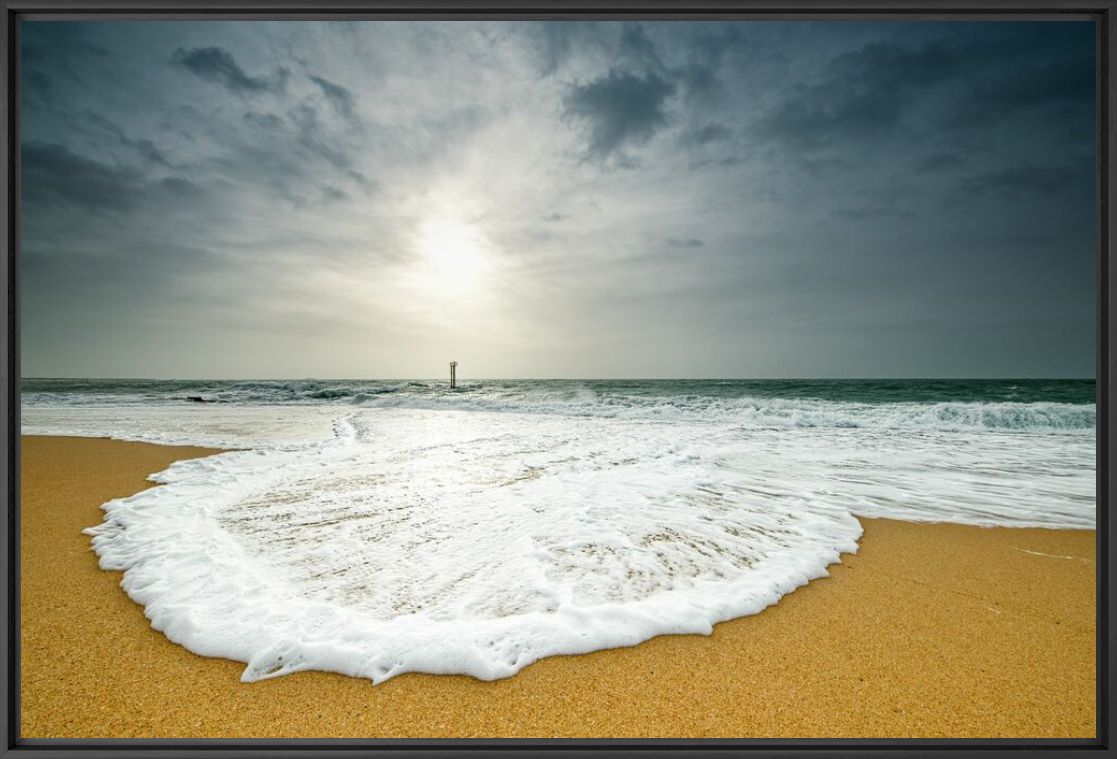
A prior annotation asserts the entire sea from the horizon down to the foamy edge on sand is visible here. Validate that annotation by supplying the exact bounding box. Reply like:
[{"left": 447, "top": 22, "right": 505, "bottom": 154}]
[{"left": 21, "top": 379, "right": 1097, "bottom": 683}]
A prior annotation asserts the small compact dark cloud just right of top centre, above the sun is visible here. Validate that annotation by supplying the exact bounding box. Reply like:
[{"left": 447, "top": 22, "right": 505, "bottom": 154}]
[{"left": 563, "top": 69, "right": 675, "bottom": 160}]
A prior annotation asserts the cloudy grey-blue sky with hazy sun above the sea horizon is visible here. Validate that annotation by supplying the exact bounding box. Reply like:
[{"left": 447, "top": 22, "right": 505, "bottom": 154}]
[{"left": 20, "top": 20, "right": 1096, "bottom": 379}]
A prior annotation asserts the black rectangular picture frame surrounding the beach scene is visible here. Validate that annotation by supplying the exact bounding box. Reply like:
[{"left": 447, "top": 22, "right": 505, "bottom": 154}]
[{"left": 0, "top": 0, "right": 1117, "bottom": 759}]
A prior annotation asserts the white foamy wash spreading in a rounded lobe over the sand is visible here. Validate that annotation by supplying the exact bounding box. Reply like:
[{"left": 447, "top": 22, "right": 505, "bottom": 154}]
[{"left": 76, "top": 409, "right": 1094, "bottom": 682}]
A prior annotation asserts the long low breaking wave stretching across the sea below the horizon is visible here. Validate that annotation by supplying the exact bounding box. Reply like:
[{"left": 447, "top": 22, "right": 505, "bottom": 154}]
[{"left": 23, "top": 381, "right": 1097, "bottom": 433}]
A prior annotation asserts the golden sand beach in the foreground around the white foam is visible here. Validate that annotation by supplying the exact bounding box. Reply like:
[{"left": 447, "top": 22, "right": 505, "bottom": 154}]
[{"left": 20, "top": 437, "right": 1095, "bottom": 738}]
